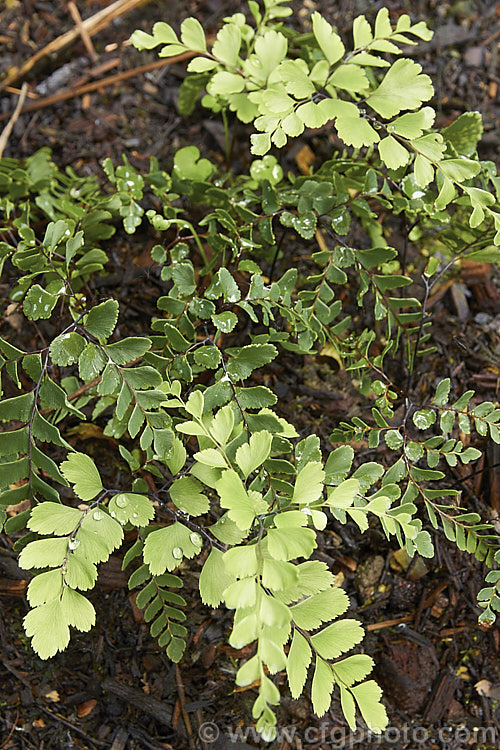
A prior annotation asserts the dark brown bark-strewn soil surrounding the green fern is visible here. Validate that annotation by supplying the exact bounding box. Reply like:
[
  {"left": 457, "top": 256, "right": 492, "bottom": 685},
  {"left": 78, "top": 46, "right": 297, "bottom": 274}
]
[{"left": 0, "top": 0, "right": 500, "bottom": 750}]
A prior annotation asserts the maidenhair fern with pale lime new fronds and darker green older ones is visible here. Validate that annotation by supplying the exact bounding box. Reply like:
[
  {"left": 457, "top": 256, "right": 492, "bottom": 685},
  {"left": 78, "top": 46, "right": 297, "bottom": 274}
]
[{"left": 0, "top": 0, "right": 500, "bottom": 740}]
